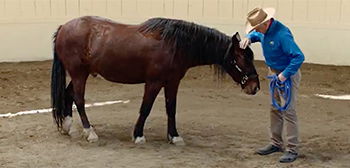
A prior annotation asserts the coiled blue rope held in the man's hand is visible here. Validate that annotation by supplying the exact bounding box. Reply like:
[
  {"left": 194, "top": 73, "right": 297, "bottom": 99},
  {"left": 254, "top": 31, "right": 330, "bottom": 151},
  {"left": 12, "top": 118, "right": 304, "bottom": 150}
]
[{"left": 267, "top": 75, "right": 292, "bottom": 112}]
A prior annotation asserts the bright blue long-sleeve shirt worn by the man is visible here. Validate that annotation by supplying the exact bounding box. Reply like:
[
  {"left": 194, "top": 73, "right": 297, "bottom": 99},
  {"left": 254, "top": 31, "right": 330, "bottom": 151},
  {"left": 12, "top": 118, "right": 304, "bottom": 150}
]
[{"left": 247, "top": 20, "right": 305, "bottom": 78}]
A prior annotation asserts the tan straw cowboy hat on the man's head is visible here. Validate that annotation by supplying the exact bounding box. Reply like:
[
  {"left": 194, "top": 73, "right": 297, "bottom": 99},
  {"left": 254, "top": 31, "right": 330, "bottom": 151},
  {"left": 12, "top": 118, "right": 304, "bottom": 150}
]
[{"left": 245, "top": 8, "right": 276, "bottom": 34}]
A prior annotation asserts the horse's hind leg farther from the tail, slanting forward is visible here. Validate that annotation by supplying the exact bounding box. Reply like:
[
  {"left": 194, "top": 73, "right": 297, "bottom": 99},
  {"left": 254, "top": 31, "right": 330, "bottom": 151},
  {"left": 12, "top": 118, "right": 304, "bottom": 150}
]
[{"left": 72, "top": 73, "right": 98, "bottom": 142}]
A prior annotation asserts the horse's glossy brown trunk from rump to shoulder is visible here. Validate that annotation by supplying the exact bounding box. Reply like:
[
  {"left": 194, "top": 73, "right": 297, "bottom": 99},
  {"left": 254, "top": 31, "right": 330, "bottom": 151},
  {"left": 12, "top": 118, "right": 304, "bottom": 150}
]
[{"left": 56, "top": 16, "right": 174, "bottom": 83}]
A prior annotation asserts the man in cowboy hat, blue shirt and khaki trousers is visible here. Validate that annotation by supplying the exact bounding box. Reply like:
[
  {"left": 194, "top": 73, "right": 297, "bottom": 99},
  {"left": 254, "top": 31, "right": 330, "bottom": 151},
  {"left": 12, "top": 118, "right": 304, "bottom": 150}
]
[{"left": 240, "top": 8, "right": 304, "bottom": 163}]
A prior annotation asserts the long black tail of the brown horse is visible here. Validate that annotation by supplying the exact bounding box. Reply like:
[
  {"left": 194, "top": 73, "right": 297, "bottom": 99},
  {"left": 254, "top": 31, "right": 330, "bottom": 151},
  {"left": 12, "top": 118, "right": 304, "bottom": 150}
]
[{"left": 51, "top": 26, "right": 66, "bottom": 129}]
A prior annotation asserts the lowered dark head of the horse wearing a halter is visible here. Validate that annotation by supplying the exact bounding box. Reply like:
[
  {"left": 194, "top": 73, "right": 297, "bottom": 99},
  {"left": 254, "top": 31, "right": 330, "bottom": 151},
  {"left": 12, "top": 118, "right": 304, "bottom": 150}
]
[{"left": 222, "top": 33, "right": 260, "bottom": 95}]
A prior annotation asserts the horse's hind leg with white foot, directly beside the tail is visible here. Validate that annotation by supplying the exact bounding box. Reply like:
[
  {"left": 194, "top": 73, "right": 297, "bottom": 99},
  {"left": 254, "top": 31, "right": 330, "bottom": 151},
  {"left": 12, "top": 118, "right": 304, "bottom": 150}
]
[{"left": 62, "top": 82, "right": 74, "bottom": 135}]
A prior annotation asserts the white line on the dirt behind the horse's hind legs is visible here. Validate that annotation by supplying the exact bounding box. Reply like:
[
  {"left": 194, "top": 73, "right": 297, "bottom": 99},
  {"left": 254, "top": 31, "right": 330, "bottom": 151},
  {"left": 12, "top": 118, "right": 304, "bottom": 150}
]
[{"left": 0, "top": 100, "right": 130, "bottom": 118}]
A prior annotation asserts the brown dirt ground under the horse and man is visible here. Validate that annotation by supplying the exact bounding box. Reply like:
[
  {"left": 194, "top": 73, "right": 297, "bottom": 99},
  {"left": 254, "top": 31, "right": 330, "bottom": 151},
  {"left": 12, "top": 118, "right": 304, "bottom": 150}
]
[{"left": 0, "top": 61, "right": 350, "bottom": 168}]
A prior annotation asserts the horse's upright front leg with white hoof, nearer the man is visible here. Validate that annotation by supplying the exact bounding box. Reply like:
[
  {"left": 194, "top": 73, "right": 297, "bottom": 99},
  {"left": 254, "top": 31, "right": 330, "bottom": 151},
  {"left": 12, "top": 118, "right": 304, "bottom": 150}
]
[{"left": 164, "top": 80, "right": 185, "bottom": 145}]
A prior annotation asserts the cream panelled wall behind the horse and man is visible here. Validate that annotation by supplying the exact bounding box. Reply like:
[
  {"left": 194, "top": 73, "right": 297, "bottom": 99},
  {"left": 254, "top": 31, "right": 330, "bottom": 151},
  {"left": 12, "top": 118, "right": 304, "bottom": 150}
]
[{"left": 0, "top": 0, "right": 350, "bottom": 65}]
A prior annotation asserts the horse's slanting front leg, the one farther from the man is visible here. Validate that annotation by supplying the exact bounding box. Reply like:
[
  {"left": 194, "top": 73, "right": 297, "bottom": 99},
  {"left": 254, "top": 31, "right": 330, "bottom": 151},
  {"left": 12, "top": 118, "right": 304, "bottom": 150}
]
[{"left": 133, "top": 82, "right": 162, "bottom": 144}]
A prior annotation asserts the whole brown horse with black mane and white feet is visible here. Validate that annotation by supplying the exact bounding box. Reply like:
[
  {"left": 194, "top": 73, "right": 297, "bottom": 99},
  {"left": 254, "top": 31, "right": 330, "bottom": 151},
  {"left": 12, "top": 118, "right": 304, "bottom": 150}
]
[{"left": 51, "top": 16, "right": 260, "bottom": 144}]
